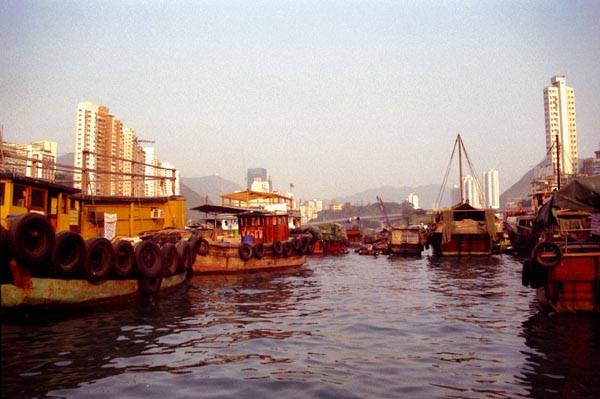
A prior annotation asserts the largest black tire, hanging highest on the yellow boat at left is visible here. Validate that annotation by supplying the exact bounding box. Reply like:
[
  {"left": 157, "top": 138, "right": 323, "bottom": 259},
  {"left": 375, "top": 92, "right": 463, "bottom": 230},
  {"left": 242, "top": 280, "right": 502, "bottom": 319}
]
[{"left": 8, "top": 213, "right": 56, "bottom": 268}]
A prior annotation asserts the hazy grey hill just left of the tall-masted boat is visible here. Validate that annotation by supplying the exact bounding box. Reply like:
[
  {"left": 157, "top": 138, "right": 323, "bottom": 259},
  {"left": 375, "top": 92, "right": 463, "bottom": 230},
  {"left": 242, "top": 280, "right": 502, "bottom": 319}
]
[{"left": 335, "top": 184, "right": 452, "bottom": 209}]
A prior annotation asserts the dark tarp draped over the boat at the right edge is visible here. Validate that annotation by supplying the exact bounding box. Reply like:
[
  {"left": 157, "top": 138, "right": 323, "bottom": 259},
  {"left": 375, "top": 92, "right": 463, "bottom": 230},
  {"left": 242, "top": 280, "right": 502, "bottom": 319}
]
[{"left": 534, "top": 176, "right": 600, "bottom": 228}]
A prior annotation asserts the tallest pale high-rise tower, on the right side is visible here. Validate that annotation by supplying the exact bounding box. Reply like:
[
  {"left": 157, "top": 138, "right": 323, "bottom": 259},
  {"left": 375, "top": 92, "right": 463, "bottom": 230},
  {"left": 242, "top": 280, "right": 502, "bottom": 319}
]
[{"left": 544, "top": 76, "right": 578, "bottom": 184}]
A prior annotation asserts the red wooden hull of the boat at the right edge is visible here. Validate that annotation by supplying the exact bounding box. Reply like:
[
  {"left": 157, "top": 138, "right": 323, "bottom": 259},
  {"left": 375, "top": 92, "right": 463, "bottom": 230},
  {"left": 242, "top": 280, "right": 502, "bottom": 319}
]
[{"left": 536, "top": 248, "right": 600, "bottom": 313}]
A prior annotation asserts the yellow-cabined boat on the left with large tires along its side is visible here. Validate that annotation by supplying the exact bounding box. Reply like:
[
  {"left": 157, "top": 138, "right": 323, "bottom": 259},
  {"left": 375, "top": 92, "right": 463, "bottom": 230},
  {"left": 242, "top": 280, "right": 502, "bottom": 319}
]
[{"left": 0, "top": 172, "right": 195, "bottom": 309}]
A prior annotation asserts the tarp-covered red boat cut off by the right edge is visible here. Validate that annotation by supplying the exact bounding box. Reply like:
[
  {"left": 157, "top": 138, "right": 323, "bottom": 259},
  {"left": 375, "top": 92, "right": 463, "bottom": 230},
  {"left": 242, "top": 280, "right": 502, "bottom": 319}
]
[{"left": 522, "top": 176, "right": 600, "bottom": 313}]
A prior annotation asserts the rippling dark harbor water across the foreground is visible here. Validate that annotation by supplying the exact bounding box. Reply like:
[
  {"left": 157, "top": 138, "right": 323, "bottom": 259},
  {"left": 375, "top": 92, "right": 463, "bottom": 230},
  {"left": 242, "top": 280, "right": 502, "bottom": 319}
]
[{"left": 1, "top": 252, "right": 600, "bottom": 399}]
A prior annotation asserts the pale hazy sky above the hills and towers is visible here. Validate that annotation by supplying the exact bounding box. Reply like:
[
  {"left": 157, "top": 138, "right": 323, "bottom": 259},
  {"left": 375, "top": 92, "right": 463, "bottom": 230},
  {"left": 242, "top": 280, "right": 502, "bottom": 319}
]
[{"left": 0, "top": 0, "right": 600, "bottom": 199}]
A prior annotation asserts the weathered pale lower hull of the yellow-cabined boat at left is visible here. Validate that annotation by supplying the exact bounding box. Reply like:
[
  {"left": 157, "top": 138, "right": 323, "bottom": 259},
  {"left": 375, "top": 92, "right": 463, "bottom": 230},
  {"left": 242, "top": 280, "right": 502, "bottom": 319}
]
[{"left": 1, "top": 268, "right": 187, "bottom": 309}]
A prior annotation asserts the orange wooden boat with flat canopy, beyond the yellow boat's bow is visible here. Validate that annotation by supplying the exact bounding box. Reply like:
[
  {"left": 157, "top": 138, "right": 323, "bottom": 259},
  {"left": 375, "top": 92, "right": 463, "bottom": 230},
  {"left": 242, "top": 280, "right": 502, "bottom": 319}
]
[{"left": 192, "top": 204, "right": 314, "bottom": 274}]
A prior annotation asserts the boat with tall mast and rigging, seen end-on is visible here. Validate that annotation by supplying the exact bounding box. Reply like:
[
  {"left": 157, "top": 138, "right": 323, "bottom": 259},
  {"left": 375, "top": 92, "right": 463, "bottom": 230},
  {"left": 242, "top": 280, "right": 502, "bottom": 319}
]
[{"left": 427, "top": 134, "right": 503, "bottom": 256}]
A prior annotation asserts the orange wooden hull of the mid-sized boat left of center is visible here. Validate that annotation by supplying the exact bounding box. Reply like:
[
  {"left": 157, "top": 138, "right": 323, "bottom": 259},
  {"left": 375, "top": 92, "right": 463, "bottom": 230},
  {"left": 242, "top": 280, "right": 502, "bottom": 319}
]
[{"left": 192, "top": 243, "right": 306, "bottom": 274}]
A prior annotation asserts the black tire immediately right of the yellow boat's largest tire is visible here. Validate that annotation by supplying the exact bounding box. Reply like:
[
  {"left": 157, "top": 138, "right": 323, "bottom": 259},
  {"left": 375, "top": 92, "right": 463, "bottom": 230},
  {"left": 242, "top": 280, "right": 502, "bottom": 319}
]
[{"left": 51, "top": 230, "right": 87, "bottom": 275}]
